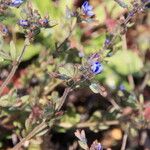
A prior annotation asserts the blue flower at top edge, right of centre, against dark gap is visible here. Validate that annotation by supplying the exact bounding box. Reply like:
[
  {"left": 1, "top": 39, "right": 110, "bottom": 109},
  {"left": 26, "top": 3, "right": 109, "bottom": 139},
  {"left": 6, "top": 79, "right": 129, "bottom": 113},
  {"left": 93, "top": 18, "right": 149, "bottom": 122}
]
[{"left": 82, "top": 1, "right": 94, "bottom": 17}]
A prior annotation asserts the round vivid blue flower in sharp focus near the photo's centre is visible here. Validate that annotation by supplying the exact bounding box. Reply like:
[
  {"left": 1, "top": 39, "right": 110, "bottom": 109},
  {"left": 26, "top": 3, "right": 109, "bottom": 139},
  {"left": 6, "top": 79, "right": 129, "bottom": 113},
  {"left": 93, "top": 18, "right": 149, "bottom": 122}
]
[{"left": 91, "top": 61, "right": 103, "bottom": 75}]
